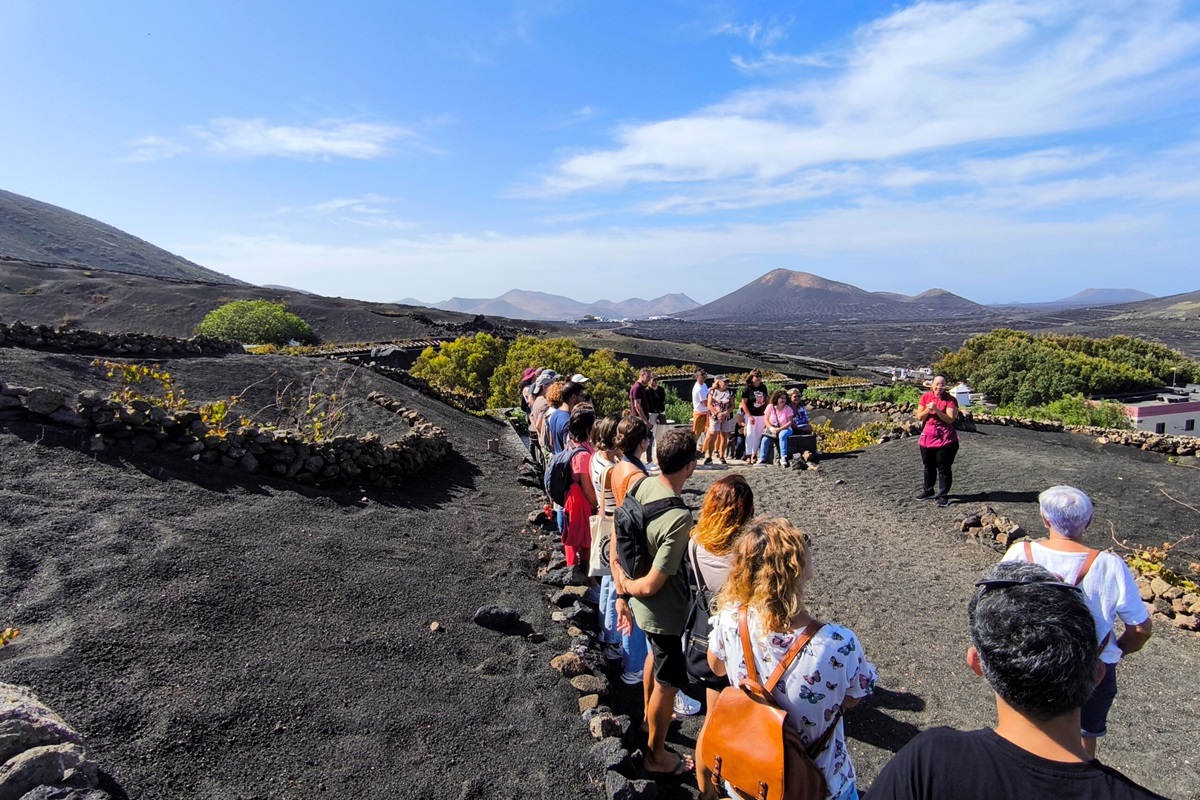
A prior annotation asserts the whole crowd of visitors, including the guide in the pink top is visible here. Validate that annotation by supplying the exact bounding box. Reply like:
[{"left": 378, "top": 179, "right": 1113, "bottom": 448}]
[{"left": 513, "top": 371, "right": 1158, "bottom": 800}]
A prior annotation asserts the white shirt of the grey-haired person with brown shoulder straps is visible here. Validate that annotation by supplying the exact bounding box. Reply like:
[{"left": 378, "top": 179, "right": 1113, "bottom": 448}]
[{"left": 1001, "top": 542, "right": 1150, "bottom": 664}]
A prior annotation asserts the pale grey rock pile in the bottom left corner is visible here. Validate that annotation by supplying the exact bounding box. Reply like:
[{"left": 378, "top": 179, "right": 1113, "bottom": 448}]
[{"left": 0, "top": 684, "right": 112, "bottom": 800}]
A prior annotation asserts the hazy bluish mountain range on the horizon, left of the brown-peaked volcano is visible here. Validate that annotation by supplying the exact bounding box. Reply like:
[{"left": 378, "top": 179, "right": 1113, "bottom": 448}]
[{"left": 400, "top": 289, "right": 700, "bottom": 321}]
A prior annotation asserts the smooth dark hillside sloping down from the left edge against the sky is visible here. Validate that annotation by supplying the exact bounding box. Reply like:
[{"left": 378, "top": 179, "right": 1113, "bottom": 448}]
[{"left": 0, "top": 190, "right": 250, "bottom": 285}]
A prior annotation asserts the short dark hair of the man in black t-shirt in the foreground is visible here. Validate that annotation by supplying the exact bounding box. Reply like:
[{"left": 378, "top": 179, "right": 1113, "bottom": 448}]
[{"left": 967, "top": 561, "right": 1099, "bottom": 721}]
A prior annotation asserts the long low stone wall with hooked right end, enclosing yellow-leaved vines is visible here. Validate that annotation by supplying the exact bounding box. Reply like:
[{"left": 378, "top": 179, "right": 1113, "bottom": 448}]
[{"left": 0, "top": 380, "right": 450, "bottom": 486}]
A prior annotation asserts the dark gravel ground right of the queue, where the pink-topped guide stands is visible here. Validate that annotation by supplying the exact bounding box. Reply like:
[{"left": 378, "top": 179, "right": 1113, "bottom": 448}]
[{"left": 648, "top": 427, "right": 1200, "bottom": 799}]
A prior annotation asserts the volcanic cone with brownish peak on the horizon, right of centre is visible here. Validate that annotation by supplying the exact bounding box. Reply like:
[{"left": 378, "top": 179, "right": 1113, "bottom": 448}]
[{"left": 679, "top": 270, "right": 995, "bottom": 323}]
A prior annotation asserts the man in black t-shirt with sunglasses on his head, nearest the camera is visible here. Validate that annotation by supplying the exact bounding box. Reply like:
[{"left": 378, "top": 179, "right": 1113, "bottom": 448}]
[{"left": 865, "top": 561, "right": 1163, "bottom": 800}]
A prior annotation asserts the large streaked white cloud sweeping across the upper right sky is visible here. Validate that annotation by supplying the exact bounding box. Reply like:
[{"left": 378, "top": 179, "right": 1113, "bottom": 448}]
[{"left": 533, "top": 0, "right": 1200, "bottom": 194}]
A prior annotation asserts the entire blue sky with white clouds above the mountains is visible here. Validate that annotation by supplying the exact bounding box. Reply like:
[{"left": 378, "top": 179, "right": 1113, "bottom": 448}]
[{"left": 0, "top": 0, "right": 1200, "bottom": 302}]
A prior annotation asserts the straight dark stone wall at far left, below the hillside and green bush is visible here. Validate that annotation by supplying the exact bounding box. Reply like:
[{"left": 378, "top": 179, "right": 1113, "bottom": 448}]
[{"left": 0, "top": 321, "right": 242, "bottom": 359}]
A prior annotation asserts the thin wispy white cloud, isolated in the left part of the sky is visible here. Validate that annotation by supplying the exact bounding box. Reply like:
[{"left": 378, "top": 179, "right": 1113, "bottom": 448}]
[{"left": 126, "top": 118, "right": 420, "bottom": 161}]
